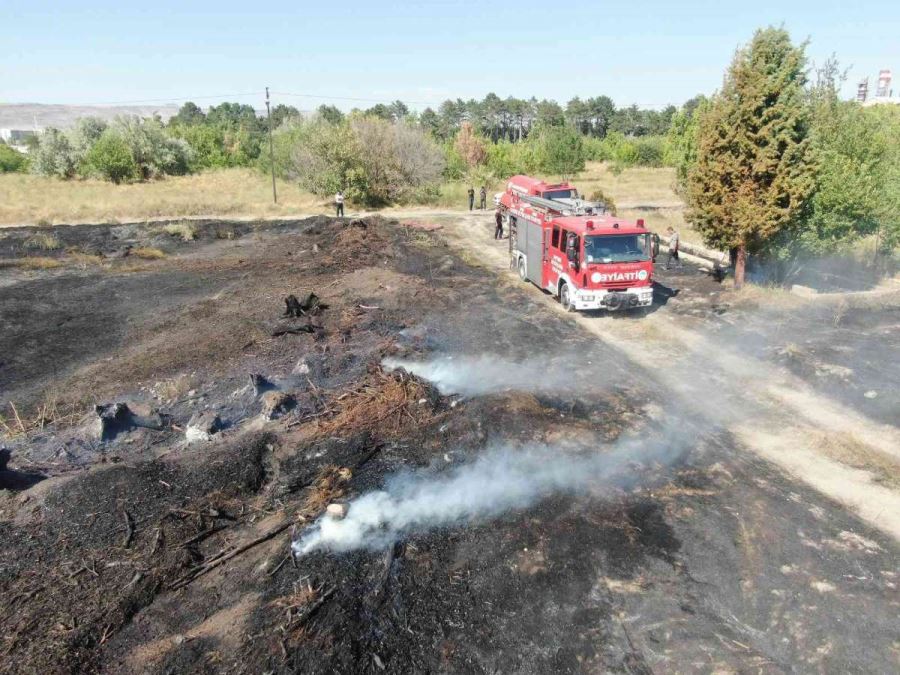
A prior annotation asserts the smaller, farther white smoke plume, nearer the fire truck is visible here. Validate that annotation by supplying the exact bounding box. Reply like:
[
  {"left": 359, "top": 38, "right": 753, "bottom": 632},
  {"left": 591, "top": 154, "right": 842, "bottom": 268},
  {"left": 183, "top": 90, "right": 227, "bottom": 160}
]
[{"left": 381, "top": 355, "right": 604, "bottom": 396}]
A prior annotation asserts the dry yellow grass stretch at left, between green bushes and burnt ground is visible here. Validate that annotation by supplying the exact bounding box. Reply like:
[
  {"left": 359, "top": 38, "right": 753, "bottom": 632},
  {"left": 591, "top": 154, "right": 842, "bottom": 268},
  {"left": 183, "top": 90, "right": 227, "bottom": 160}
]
[{"left": 0, "top": 169, "right": 328, "bottom": 225}]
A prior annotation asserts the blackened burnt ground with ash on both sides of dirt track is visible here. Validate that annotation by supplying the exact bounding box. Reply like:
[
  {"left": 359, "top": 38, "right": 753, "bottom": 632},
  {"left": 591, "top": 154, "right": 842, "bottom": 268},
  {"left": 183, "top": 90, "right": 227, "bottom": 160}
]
[{"left": 0, "top": 218, "right": 900, "bottom": 673}]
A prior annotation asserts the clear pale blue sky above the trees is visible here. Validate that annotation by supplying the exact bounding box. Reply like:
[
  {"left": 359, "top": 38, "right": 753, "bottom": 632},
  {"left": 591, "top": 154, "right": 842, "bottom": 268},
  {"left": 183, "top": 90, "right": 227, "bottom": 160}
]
[{"left": 0, "top": 0, "right": 900, "bottom": 109}]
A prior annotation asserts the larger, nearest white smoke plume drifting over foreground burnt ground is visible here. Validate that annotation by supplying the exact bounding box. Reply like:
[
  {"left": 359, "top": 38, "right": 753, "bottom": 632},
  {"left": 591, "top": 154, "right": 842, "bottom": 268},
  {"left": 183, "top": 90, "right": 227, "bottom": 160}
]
[{"left": 293, "top": 436, "right": 687, "bottom": 556}]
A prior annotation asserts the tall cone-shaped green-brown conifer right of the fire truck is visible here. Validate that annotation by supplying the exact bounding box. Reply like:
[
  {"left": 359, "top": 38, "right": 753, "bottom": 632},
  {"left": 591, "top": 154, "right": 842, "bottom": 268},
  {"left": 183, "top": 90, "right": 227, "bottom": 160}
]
[{"left": 686, "top": 28, "right": 814, "bottom": 288}]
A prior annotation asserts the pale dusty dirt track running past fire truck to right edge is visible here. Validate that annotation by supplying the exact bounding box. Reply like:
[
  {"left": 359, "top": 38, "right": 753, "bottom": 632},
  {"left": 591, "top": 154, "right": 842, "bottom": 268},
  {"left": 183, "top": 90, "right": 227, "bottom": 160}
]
[{"left": 432, "top": 214, "right": 900, "bottom": 540}]
